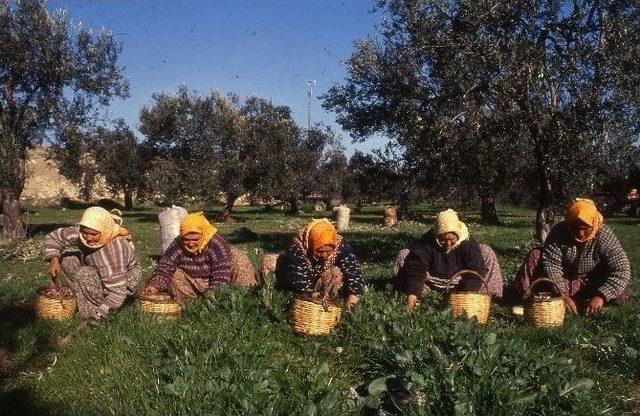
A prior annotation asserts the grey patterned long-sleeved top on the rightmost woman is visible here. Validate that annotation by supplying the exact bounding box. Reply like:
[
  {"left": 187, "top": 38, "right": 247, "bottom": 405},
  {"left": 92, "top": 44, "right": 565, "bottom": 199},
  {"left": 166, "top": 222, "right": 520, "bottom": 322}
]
[{"left": 542, "top": 221, "right": 631, "bottom": 301}]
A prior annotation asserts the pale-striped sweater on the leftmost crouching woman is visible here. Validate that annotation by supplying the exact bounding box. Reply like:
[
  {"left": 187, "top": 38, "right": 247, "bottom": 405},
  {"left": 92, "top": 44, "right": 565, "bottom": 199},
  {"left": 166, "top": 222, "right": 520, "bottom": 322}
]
[{"left": 44, "top": 226, "right": 138, "bottom": 315}]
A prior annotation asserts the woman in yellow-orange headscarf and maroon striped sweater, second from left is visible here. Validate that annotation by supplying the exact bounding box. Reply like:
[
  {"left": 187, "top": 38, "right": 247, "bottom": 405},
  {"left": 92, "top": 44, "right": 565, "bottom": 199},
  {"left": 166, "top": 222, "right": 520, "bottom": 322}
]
[{"left": 144, "top": 212, "right": 255, "bottom": 299}]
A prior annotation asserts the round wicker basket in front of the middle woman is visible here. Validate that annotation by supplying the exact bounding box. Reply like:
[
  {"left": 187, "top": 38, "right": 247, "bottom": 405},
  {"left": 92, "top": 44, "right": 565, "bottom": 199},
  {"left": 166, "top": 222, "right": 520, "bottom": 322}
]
[{"left": 291, "top": 298, "right": 342, "bottom": 335}]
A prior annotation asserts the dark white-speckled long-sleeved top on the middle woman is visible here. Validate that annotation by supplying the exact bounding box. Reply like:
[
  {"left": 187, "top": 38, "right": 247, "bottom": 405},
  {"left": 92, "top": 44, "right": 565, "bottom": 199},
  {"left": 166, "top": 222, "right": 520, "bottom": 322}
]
[{"left": 286, "top": 240, "right": 364, "bottom": 295}]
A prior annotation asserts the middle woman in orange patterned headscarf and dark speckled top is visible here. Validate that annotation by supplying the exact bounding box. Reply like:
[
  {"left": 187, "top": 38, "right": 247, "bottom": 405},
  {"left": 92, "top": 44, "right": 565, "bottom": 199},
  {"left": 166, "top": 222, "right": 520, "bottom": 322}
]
[{"left": 274, "top": 218, "right": 364, "bottom": 311}]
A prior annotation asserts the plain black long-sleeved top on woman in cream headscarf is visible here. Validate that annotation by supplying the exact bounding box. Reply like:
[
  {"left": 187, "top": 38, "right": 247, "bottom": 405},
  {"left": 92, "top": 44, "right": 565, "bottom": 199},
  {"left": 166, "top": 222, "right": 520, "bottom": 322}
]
[{"left": 398, "top": 231, "right": 487, "bottom": 296}]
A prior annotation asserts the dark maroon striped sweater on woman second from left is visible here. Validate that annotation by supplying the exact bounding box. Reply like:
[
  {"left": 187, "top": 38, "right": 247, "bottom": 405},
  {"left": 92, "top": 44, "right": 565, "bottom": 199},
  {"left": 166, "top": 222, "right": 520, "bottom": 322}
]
[{"left": 149, "top": 234, "right": 233, "bottom": 292}]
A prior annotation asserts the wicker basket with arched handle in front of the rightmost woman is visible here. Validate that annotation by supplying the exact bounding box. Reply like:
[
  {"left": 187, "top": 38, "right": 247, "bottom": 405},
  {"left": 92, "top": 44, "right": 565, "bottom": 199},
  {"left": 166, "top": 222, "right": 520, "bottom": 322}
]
[{"left": 524, "top": 278, "right": 565, "bottom": 328}]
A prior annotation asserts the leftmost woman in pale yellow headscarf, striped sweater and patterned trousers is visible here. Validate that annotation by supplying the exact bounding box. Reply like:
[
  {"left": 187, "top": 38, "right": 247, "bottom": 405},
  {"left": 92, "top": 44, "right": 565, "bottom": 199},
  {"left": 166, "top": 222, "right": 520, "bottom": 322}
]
[{"left": 44, "top": 207, "right": 143, "bottom": 319}]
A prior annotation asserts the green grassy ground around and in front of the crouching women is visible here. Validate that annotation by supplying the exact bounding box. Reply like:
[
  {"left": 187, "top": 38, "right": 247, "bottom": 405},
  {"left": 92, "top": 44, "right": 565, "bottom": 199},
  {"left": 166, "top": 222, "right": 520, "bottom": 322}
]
[{"left": 0, "top": 203, "right": 640, "bottom": 415}]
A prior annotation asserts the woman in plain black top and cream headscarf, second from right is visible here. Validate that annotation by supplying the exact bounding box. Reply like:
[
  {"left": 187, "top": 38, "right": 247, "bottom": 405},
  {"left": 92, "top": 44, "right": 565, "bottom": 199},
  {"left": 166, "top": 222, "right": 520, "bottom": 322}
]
[{"left": 394, "top": 209, "right": 503, "bottom": 310}]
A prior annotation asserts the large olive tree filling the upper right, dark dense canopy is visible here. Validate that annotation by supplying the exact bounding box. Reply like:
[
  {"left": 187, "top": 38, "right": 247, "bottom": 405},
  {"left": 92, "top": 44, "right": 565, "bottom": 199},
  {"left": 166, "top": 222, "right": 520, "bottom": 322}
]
[{"left": 324, "top": 0, "right": 640, "bottom": 239}]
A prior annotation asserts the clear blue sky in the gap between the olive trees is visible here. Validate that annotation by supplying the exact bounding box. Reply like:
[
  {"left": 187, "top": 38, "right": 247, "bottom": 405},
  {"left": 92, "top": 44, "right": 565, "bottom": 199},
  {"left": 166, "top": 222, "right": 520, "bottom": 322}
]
[{"left": 48, "top": 0, "right": 384, "bottom": 154}]
